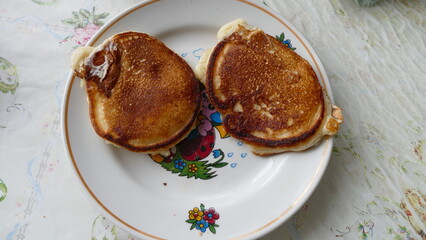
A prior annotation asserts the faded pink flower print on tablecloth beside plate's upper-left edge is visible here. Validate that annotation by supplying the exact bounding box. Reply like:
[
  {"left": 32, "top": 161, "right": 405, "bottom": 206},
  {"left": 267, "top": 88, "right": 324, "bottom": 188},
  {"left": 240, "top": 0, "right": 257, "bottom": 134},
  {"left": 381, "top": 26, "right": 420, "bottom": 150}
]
[{"left": 62, "top": 7, "right": 109, "bottom": 46}]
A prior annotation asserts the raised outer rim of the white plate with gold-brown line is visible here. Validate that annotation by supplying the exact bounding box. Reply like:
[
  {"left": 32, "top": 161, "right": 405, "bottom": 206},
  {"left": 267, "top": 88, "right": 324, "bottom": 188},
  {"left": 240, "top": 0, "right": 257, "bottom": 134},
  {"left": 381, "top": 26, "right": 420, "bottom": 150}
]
[{"left": 61, "top": 0, "right": 334, "bottom": 239}]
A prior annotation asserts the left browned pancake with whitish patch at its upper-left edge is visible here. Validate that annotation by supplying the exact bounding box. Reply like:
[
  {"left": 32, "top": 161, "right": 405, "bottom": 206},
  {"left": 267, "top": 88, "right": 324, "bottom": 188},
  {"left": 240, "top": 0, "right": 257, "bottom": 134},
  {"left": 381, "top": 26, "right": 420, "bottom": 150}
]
[{"left": 76, "top": 32, "right": 201, "bottom": 153}]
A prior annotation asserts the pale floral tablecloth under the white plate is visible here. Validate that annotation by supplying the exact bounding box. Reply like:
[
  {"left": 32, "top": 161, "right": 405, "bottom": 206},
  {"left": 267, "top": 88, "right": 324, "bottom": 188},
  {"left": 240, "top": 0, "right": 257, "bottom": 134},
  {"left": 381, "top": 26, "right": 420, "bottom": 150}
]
[{"left": 0, "top": 0, "right": 426, "bottom": 240}]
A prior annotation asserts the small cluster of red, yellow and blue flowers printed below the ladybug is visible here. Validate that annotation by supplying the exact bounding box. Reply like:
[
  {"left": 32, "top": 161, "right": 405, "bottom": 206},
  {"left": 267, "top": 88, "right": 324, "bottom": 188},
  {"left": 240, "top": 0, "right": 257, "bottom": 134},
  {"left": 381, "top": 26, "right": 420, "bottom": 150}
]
[{"left": 186, "top": 203, "right": 220, "bottom": 234}]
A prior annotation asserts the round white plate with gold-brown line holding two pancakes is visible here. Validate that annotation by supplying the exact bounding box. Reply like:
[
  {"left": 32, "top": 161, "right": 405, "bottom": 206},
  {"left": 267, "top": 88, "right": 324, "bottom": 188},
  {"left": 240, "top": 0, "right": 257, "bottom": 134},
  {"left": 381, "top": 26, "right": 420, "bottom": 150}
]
[{"left": 63, "top": 0, "right": 332, "bottom": 239}]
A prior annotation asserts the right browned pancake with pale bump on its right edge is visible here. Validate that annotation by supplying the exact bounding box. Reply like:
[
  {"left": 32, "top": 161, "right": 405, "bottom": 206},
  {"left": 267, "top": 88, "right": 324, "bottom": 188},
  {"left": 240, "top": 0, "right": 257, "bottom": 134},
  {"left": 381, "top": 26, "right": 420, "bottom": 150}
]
[{"left": 197, "top": 20, "right": 343, "bottom": 155}]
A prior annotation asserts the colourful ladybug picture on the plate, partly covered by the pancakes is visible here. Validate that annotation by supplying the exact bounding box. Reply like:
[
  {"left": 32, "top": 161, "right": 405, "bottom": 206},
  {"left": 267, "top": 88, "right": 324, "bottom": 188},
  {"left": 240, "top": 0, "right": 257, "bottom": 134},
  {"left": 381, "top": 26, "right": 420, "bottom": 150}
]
[{"left": 150, "top": 90, "right": 229, "bottom": 180}]
